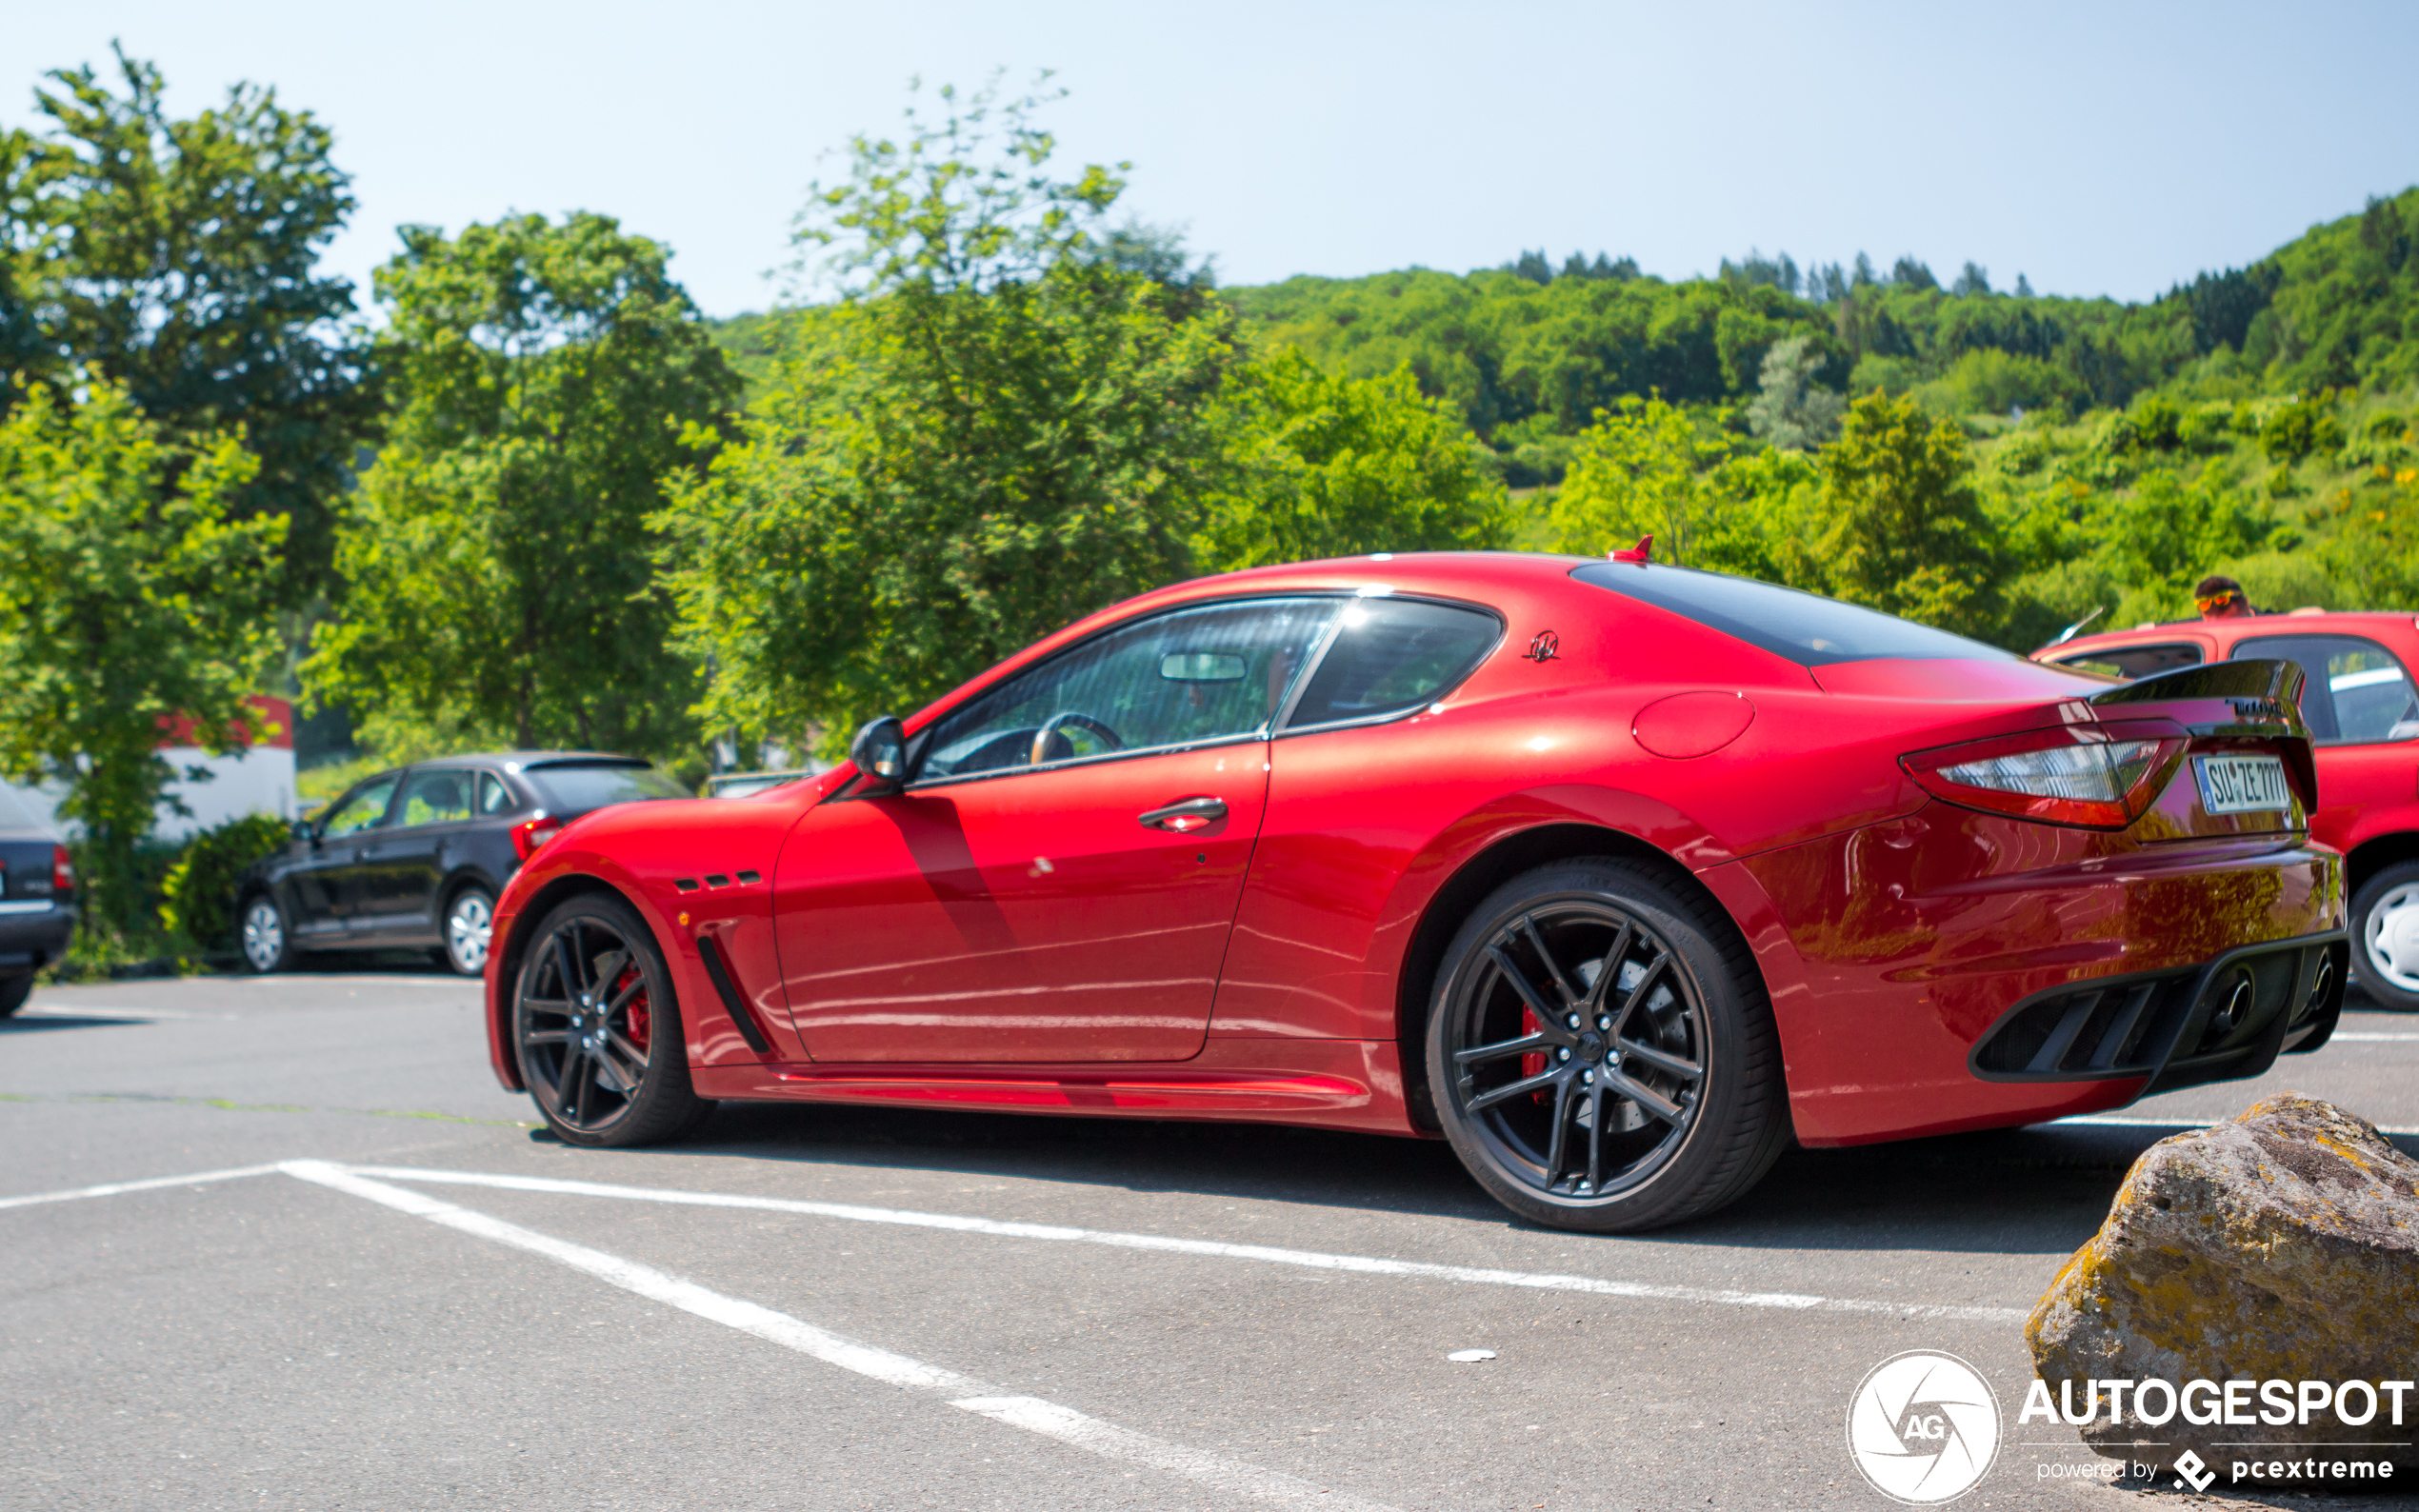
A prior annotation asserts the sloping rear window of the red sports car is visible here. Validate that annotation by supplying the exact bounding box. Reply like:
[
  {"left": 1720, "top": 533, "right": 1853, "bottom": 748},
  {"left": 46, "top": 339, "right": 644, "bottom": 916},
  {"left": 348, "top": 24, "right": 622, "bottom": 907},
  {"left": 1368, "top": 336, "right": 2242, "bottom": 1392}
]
[{"left": 1569, "top": 561, "right": 2017, "bottom": 667}]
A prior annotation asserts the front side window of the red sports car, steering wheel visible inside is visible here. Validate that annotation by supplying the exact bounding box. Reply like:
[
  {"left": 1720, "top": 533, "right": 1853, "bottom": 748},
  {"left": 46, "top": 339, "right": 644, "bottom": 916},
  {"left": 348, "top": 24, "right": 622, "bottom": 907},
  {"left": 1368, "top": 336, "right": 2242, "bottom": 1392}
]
[{"left": 917, "top": 598, "right": 1340, "bottom": 782}]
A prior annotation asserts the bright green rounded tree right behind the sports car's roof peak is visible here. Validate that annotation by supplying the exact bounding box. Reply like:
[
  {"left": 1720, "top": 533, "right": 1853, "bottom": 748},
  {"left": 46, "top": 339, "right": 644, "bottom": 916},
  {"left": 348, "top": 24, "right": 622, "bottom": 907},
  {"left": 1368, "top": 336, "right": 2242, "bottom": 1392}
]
[{"left": 1195, "top": 348, "right": 1507, "bottom": 571}]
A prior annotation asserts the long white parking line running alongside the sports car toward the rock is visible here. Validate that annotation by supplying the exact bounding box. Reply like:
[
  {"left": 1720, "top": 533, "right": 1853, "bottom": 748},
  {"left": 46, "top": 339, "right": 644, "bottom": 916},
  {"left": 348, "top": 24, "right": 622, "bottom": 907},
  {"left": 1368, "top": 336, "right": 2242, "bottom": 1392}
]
[{"left": 346, "top": 1166, "right": 2032, "bottom": 1323}]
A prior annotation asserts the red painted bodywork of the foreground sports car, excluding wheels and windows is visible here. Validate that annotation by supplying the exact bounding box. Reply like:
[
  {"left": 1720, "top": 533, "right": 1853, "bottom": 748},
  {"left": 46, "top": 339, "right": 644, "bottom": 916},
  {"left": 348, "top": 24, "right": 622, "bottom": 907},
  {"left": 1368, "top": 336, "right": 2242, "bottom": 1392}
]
[{"left": 487, "top": 554, "right": 2344, "bottom": 1165}]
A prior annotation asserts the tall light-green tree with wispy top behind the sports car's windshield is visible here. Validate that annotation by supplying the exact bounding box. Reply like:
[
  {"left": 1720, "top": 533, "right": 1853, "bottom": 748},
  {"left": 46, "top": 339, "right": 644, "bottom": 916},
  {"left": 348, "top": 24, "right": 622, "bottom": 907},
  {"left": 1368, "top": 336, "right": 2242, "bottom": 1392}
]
[{"left": 658, "top": 79, "right": 1236, "bottom": 738}]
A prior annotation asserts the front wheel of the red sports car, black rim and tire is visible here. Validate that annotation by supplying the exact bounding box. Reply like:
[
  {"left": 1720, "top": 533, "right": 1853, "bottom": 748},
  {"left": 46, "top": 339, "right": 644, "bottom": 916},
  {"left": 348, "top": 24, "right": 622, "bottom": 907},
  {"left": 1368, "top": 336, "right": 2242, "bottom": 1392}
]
[{"left": 512, "top": 893, "right": 709, "bottom": 1149}]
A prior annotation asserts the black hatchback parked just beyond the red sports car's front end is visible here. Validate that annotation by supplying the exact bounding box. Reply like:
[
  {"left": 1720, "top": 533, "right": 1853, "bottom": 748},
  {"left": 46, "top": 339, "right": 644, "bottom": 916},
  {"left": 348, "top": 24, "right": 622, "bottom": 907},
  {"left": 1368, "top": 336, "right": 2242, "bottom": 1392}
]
[{"left": 234, "top": 750, "right": 694, "bottom": 977}]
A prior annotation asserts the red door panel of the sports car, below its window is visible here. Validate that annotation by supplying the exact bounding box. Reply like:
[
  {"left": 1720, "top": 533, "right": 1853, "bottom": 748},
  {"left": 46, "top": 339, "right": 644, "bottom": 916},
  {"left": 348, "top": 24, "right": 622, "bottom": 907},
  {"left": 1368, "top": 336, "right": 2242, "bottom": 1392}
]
[{"left": 774, "top": 740, "right": 1268, "bottom": 1062}]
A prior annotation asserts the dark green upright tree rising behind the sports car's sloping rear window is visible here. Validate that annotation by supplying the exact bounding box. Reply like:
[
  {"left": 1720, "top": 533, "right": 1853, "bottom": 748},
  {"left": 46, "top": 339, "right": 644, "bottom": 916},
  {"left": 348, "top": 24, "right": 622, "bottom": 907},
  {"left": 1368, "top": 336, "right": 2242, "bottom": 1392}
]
[{"left": 1817, "top": 394, "right": 2006, "bottom": 636}]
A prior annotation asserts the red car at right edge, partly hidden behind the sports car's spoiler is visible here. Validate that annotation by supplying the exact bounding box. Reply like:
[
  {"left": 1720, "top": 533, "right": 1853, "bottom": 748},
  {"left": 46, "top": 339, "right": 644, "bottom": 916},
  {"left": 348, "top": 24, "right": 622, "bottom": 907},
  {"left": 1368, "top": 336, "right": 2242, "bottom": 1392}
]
[{"left": 2032, "top": 609, "right": 2419, "bottom": 1011}]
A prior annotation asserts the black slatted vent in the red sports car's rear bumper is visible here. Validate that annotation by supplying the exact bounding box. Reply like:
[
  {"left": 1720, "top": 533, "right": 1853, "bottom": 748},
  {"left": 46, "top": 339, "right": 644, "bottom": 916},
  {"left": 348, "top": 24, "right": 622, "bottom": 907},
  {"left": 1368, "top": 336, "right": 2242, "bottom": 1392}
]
[{"left": 1967, "top": 934, "right": 2347, "bottom": 1093}]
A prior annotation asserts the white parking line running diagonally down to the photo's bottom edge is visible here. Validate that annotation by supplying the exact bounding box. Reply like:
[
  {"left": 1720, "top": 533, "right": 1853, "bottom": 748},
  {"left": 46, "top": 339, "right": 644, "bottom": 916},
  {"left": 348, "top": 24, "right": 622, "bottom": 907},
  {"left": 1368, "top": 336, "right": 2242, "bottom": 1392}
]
[{"left": 278, "top": 1162, "right": 1391, "bottom": 1512}]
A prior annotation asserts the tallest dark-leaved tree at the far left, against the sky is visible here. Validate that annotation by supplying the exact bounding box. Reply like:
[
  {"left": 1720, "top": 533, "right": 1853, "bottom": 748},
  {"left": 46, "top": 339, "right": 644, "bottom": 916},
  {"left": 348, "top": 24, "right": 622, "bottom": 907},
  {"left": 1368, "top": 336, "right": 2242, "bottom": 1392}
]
[{"left": 0, "top": 50, "right": 377, "bottom": 607}]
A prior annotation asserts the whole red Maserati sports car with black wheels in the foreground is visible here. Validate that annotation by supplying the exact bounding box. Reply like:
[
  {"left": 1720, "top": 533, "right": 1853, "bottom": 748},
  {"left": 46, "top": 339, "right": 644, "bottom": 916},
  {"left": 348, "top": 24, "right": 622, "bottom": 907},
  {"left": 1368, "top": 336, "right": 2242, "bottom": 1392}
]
[{"left": 487, "top": 551, "right": 2347, "bottom": 1229}]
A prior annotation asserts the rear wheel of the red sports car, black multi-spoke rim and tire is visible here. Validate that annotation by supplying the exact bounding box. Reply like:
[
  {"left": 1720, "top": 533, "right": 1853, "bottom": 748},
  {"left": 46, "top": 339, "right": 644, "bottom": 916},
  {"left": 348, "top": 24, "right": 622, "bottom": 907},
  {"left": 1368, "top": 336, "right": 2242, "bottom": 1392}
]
[{"left": 1428, "top": 856, "right": 1790, "bottom": 1234}]
